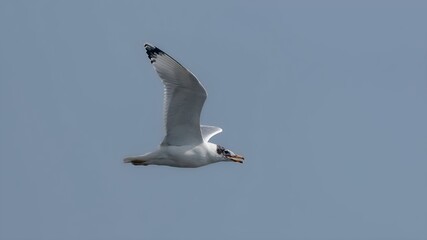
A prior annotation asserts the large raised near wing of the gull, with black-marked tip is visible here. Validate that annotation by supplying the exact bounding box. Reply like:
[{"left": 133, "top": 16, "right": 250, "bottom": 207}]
[{"left": 144, "top": 43, "right": 207, "bottom": 146}]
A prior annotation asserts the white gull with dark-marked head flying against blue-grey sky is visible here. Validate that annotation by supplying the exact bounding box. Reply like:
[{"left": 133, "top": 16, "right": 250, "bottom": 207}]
[{"left": 124, "top": 43, "right": 244, "bottom": 168}]
